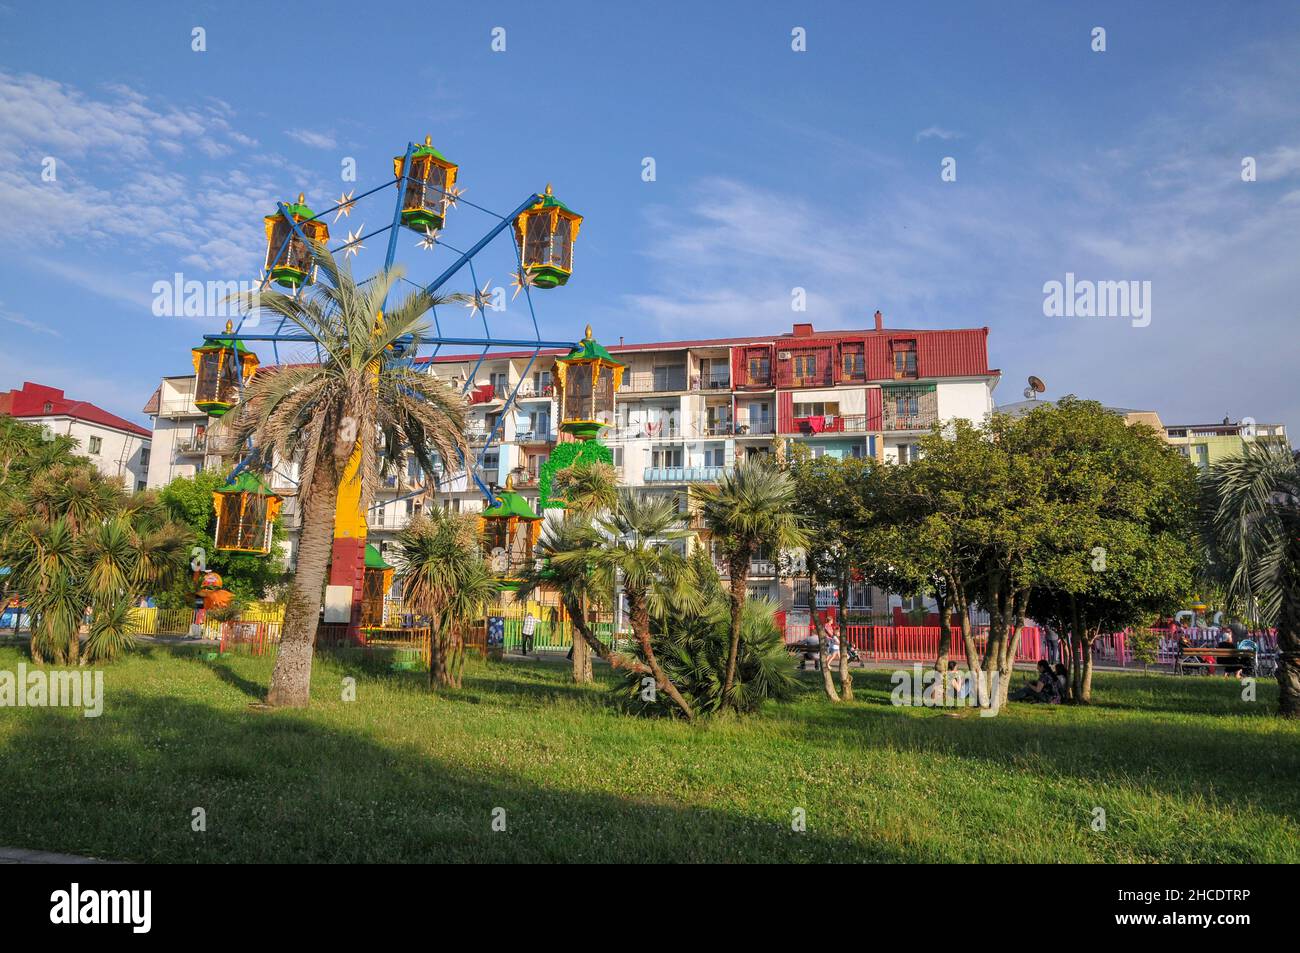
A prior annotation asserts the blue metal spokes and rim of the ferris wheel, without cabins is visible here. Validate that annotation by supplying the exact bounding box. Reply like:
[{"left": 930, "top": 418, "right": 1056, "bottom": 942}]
[{"left": 203, "top": 142, "right": 579, "bottom": 510}]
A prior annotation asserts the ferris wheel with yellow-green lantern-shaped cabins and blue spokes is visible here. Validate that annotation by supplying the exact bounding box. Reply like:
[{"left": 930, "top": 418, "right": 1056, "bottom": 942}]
[{"left": 192, "top": 138, "right": 623, "bottom": 638}]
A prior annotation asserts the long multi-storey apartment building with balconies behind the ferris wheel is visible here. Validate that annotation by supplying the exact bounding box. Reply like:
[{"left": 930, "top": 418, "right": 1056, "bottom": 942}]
[{"left": 146, "top": 312, "right": 1000, "bottom": 611}]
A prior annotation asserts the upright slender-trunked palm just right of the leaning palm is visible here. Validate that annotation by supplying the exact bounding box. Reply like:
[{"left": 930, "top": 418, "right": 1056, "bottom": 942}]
[{"left": 699, "top": 459, "right": 809, "bottom": 712}]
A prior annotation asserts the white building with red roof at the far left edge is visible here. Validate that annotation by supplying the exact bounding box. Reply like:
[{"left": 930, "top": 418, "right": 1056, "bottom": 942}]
[{"left": 0, "top": 381, "right": 151, "bottom": 493}]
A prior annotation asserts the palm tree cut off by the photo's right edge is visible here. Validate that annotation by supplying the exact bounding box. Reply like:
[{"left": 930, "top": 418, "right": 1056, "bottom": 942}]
[{"left": 1205, "top": 442, "right": 1300, "bottom": 718}]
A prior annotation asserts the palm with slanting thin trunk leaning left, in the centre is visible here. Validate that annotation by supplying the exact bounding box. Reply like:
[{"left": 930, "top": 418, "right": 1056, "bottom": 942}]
[{"left": 551, "top": 489, "right": 694, "bottom": 719}]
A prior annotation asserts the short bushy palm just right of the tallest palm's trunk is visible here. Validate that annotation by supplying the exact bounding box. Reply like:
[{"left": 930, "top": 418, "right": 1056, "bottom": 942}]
[{"left": 397, "top": 510, "right": 497, "bottom": 688}]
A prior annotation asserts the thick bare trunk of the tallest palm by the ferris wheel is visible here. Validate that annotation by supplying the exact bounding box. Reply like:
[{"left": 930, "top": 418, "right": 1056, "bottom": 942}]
[{"left": 267, "top": 454, "right": 338, "bottom": 709}]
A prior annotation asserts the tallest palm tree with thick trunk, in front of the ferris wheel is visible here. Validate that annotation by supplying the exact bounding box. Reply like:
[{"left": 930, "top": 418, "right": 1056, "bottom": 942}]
[{"left": 233, "top": 246, "right": 465, "bottom": 707}]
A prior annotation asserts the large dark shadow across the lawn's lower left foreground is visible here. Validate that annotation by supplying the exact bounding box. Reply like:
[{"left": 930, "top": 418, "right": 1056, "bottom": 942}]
[{"left": 0, "top": 686, "right": 906, "bottom": 863}]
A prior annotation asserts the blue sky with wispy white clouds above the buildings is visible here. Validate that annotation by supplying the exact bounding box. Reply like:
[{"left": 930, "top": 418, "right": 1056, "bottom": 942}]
[{"left": 0, "top": 0, "right": 1300, "bottom": 430}]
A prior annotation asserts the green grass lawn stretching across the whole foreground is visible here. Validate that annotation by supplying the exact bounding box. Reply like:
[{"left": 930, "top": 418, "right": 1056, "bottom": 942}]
[{"left": 0, "top": 646, "right": 1300, "bottom": 863}]
